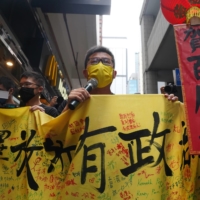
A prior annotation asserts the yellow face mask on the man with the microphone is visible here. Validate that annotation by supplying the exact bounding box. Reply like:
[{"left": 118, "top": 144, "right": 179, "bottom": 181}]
[{"left": 87, "top": 62, "right": 113, "bottom": 88}]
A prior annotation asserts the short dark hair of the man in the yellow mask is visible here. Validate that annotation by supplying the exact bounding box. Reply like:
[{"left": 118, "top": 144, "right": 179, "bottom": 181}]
[{"left": 85, "top": 46, "right": 115, "bottom": 69}]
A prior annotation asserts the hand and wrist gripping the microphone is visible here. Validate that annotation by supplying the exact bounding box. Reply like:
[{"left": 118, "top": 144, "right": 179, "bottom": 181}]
[{"left": 62, "top": 88, "right": 90, "bottom": 113}]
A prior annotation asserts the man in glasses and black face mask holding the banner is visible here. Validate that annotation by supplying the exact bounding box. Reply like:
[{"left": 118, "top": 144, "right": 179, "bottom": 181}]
[{"left": 19, "top": 71, "right": 59, "bottom": 117}]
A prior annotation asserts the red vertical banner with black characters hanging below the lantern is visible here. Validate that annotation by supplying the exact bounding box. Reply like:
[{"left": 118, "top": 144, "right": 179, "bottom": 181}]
[{"left": 174, "top": 24, "right": 200, "bottom": 154}]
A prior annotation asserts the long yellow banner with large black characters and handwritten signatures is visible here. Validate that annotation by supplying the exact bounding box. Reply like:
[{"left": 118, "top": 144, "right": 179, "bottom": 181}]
[{"left": 0, "top": 95, "right": 200, "bottom": 200}]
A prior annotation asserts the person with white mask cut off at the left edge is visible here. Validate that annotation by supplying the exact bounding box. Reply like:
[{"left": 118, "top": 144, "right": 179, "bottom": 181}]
[{"left": 0, "top": 76, "right": 17, "bottom": 108}]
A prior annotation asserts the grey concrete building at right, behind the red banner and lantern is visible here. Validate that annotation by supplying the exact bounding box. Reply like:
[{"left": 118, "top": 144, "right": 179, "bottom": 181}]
[{"left": 140, "top": 0, "right": 178, "bottom": 94}]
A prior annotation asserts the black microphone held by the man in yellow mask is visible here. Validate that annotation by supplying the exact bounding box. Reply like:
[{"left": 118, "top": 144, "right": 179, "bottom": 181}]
[{"left": 68, "top": 78, "right": 98, "bottom": 110}]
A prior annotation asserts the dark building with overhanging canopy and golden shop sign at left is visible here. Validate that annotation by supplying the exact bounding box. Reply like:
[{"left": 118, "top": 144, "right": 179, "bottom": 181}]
[{"left": 0, "top": 0, "right": 111, "bottom": 101}]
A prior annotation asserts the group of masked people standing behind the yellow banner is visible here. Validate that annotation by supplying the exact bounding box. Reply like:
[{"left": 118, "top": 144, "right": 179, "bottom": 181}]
[{"left": 0, "top": 46, "right": 178, "bottom": 117}]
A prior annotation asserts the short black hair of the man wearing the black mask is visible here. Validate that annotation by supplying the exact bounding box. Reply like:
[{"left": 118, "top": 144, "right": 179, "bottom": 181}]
[{"left": 20, "top": 71, "right": 45, "bottom": 87}]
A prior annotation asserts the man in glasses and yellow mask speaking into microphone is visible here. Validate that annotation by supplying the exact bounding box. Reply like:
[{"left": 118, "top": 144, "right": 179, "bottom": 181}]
[{"left": 58, "top": 46, "right": 178, "bottom": 112}]
